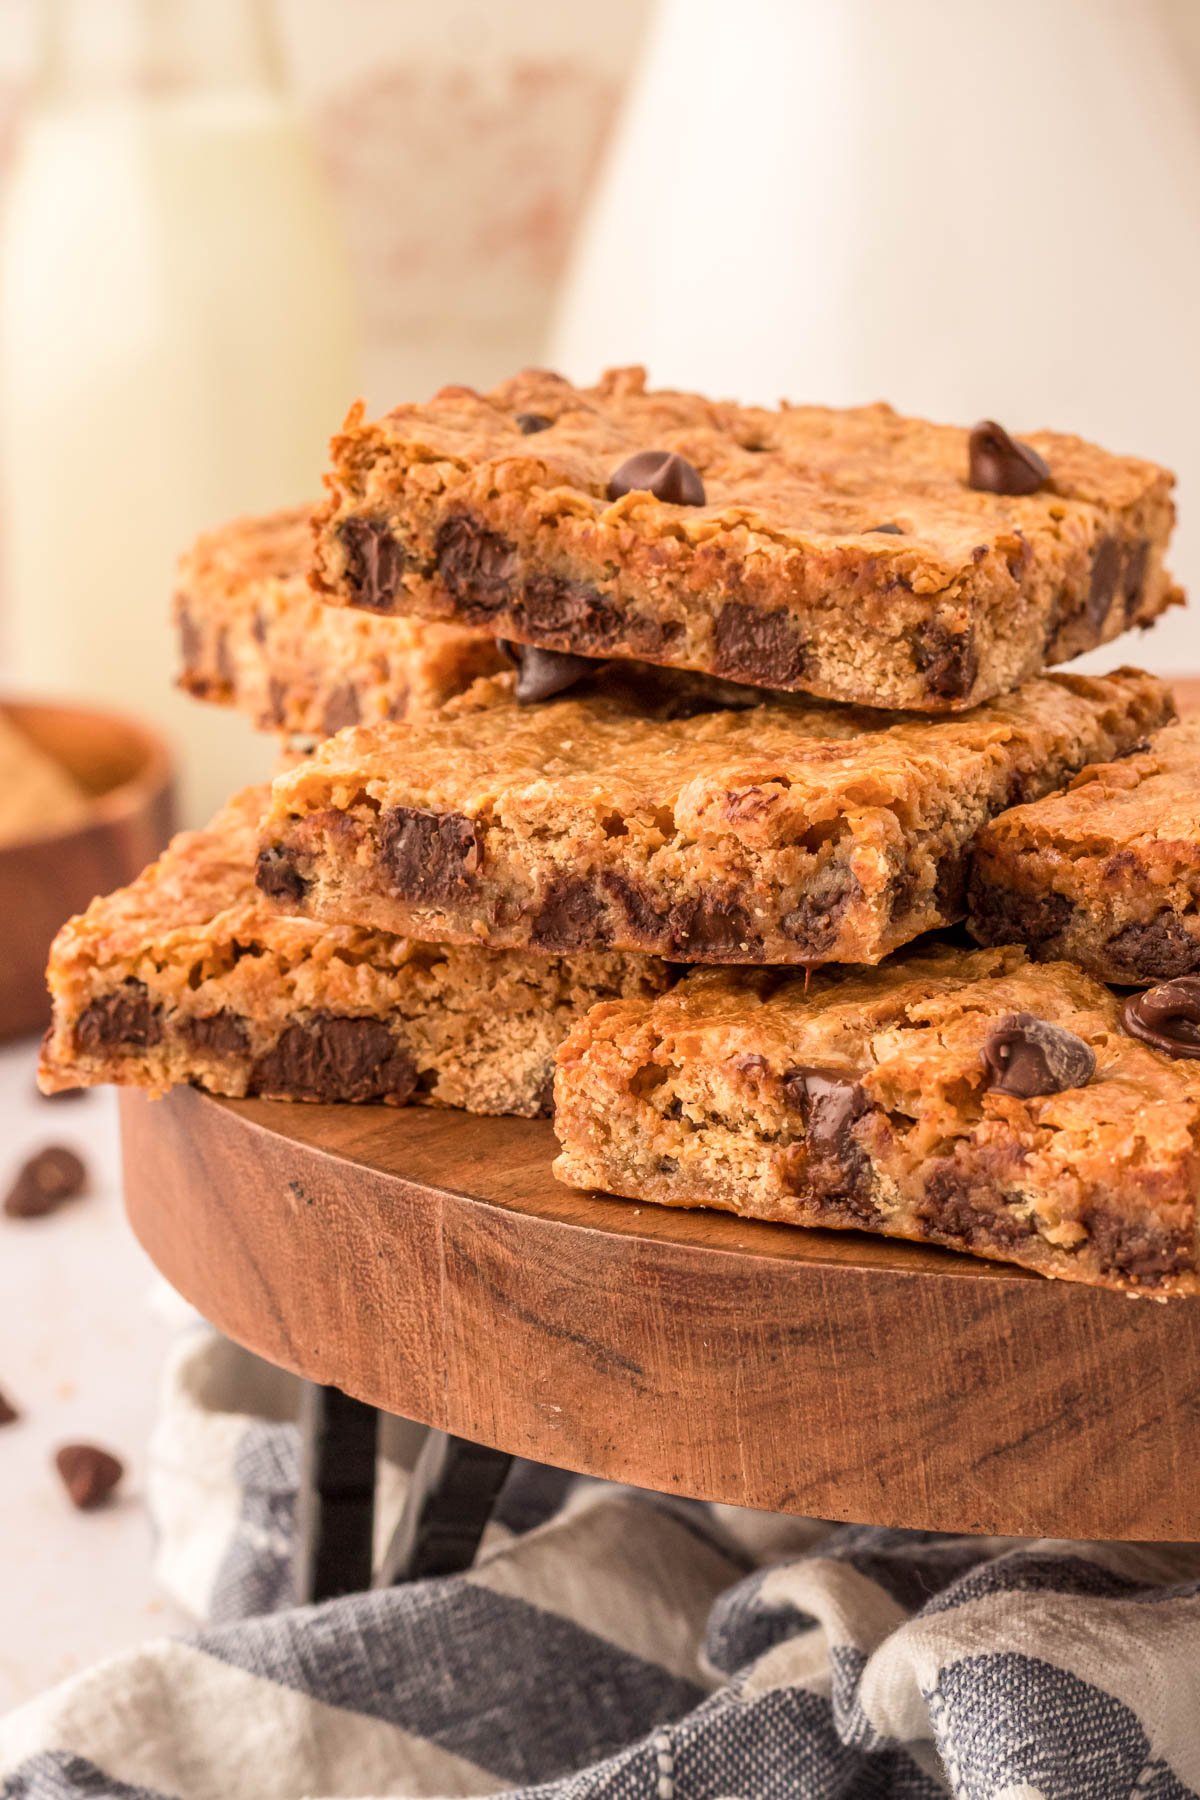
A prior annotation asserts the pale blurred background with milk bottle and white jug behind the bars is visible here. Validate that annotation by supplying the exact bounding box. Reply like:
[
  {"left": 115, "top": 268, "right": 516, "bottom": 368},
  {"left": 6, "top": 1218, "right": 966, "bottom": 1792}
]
[{"left": 0, "top": 0, "right": 1200, "bottom": 815}]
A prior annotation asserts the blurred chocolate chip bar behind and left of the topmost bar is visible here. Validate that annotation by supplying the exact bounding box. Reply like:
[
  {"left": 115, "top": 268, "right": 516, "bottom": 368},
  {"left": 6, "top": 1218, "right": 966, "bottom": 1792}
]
[{"left": 175, "top": 508, "right": 506, "bottom": 738}]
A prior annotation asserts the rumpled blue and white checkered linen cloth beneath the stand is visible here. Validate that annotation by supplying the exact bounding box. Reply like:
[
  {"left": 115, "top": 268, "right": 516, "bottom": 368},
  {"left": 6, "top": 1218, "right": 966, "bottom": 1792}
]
[{"left": 0, "top": 1330, "right": 1200, "bottom": 1800}]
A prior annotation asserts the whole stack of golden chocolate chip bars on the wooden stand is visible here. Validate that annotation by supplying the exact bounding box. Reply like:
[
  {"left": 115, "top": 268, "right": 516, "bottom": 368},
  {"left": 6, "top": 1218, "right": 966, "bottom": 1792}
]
[{"left": 43, "top": 369, "right": 1200, "bottom": 1296}]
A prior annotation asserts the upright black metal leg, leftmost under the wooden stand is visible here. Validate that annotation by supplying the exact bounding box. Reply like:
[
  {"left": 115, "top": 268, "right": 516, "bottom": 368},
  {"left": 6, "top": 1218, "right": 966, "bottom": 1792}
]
[{"left": 295, "top": 1382, "right": 378, "bottom": 1606}]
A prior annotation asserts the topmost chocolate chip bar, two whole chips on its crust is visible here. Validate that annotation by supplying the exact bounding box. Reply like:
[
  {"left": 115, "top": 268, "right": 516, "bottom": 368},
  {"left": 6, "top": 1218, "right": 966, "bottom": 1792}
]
[{"left": 315, "top": 369, "right": 1178, "bottom": 711}]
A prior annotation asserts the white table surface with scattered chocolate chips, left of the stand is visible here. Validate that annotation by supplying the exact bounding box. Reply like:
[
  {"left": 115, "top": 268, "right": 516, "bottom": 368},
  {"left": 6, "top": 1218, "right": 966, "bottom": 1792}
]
[{"left": 0, "top": 1040, "right": 191, "bottom": 1712}]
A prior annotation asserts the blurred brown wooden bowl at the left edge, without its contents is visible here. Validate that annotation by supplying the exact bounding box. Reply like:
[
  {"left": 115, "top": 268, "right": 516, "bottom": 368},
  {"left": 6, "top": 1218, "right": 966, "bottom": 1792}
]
[{"left": 0, "top": 702, "right": 173, "bottom": 1040}]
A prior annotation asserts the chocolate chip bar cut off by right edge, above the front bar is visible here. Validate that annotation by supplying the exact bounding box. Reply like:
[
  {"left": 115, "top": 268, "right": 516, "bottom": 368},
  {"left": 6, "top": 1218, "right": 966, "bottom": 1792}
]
[{"left": 970, "top": 718, "right": 1200, "bottom": 985}]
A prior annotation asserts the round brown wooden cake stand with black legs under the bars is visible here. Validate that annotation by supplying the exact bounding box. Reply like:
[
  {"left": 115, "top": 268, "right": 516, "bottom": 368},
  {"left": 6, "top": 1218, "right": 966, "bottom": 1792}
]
[{"left": 121, "top": 1089, "right": 1200, "bottom": 1593}]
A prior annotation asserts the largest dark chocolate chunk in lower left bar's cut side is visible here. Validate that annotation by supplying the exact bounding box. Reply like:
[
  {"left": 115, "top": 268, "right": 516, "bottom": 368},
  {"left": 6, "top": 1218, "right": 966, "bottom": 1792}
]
[{"left": 250, "top": 1012, "right": 417, "bottom": 1102}]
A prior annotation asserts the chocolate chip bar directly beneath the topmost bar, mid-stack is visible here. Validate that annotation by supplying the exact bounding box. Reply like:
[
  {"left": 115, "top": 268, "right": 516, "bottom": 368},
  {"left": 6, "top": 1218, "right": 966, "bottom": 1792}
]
[{"left": 259, "top": 666, "right": 1171, "bottom": 965}]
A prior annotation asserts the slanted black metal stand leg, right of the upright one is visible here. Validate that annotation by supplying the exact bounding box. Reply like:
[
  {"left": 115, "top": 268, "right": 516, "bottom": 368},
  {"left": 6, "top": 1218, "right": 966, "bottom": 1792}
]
[{"left": 376, "top": 1431, "right": 513, "bottom": 1588}]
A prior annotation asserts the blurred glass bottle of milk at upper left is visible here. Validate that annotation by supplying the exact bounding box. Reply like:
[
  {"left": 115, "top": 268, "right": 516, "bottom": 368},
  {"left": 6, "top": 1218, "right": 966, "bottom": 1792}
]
[{"left": 0, "top": 0, "right": 356, "bottom": 819}]
